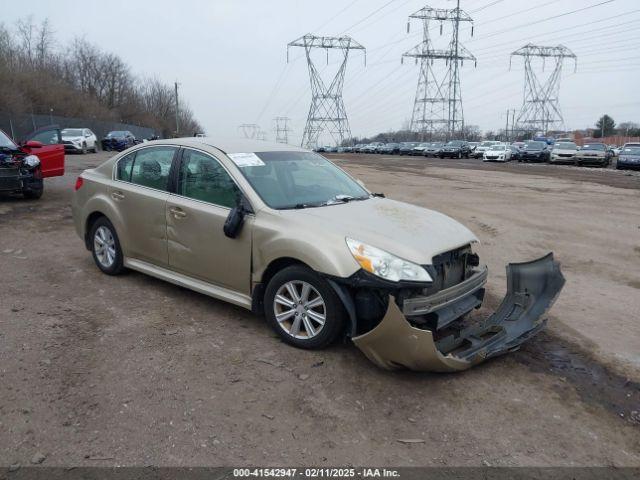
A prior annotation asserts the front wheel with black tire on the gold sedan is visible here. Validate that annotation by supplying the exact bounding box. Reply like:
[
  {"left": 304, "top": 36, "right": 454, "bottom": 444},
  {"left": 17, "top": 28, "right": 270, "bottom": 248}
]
[{"left": 264, "top": 265, "right": 346, "bottom": 349}]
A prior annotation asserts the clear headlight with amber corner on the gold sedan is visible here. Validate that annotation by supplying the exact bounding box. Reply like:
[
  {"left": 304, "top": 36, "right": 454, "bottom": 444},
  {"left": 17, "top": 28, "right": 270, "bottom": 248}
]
[{"left": 346, "top": 238, "right": 433, "bottom": 282}]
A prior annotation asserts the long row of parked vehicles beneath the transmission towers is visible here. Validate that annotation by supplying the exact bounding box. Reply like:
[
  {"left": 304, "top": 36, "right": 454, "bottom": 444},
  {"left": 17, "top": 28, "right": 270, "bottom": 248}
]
[{"left": 316, "top": 139, "right": 640, "bottom": 169}]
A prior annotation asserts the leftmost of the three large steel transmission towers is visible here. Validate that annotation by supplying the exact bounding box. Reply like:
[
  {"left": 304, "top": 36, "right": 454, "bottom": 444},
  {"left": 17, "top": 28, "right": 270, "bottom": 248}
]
[{"left": 287, "top": 34, "right": 366, "bottom": 148}]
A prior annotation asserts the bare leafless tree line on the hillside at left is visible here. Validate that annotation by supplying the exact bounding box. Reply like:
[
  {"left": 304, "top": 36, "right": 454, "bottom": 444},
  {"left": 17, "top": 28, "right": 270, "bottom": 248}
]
[{"left": 0, "top": 17, "right": 202, "bottom": 137}]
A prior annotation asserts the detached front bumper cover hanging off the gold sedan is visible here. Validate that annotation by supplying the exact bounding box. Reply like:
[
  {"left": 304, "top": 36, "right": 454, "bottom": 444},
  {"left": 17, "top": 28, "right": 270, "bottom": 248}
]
[{"left": 353, "top": 253, "right": 564, "bottom": 372}]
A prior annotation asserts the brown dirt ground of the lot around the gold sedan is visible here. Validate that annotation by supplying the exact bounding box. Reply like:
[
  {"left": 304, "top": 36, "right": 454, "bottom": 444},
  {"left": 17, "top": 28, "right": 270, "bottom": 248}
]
[{"left": 0, "top": 153, "right": 640, "bottom": 466}]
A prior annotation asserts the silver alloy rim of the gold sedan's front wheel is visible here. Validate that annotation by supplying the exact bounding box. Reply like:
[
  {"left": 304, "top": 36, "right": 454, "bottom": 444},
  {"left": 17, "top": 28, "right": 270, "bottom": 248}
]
[{"left": 273, "top": 280, "right": 327, "bottom": 340}]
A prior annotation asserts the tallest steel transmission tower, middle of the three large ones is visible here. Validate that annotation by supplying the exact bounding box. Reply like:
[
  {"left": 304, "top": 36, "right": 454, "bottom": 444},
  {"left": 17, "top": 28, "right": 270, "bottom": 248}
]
[{"left": 402, "top": 0, "right": 476, "bottom": 140}]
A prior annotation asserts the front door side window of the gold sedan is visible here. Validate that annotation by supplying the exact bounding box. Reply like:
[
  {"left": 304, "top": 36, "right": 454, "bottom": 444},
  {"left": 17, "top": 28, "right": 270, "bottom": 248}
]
[{"left": 178, "top": 149, "right": 240, "bottom": 208}]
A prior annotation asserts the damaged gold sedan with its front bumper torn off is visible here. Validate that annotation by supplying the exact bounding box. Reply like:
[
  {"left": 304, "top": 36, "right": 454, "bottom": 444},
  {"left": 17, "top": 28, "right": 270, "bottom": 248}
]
[{"left": 72, "top": 137, "right": 564, "bottom": 371}]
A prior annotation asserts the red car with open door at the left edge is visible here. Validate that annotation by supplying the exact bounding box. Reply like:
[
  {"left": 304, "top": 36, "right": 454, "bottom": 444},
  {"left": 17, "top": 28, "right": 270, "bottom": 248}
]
[{"left": 0, "top": 125, "right": 64, "bottom": 199}]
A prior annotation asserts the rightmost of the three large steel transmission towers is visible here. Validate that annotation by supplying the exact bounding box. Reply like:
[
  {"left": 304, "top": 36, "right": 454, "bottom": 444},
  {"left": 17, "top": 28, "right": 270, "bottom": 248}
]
[{"left": 509, "top": 43, "right": 578, "bottom": 136}]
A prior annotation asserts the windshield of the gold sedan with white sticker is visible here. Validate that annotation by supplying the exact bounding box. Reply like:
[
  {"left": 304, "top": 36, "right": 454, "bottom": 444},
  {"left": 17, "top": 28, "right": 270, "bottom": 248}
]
[{"left": 238, "top": 152, "right": 369, "bottom": 210}]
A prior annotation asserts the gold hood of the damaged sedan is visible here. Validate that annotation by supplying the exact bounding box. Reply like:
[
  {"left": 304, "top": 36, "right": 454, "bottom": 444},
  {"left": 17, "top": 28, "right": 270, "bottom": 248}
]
[{"left": 282, "top": 198, "right": 478, "bottom": 265}]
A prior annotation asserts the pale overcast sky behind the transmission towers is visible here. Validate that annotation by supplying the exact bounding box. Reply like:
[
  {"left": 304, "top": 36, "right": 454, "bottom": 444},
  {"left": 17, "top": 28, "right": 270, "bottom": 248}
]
[{"left": 1, "top": 0, "right": 640, "bottom": 142}]
